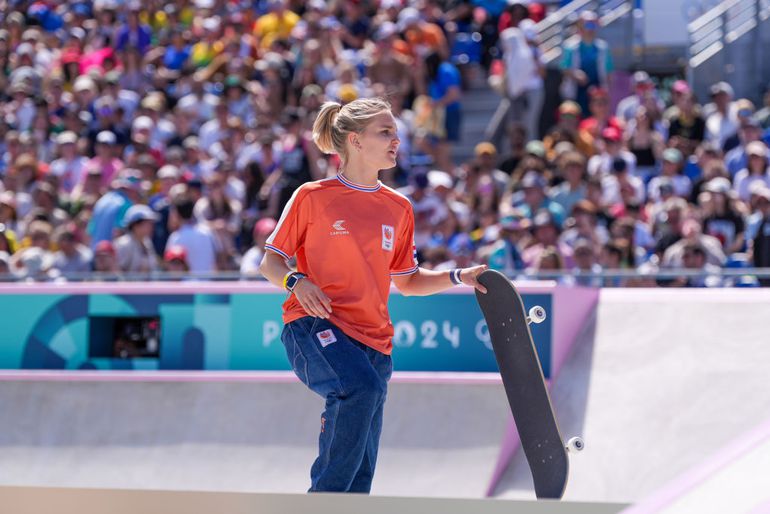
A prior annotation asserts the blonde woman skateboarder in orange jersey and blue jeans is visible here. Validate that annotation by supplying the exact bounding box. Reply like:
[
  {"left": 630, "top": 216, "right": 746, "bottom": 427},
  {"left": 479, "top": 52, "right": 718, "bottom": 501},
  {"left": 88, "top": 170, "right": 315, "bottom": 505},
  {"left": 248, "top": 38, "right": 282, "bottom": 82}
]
[{"left": 260, "top": 99, "right": 486, "bottom": 493}]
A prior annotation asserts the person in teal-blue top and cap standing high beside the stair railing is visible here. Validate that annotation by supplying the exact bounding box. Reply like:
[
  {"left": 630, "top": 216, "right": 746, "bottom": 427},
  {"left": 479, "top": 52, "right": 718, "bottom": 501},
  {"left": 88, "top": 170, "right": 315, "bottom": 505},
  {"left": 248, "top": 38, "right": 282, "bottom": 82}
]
[{"left": 560, "top": 11, "right": 613, "bottom": 116}]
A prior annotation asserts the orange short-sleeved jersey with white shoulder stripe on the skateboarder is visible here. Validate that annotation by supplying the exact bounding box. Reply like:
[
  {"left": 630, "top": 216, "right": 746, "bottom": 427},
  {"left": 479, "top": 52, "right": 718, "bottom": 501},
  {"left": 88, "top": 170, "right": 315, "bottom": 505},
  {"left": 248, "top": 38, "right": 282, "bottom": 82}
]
[{"left": 265, "top": 175, "right": 417, "bottom": 355}]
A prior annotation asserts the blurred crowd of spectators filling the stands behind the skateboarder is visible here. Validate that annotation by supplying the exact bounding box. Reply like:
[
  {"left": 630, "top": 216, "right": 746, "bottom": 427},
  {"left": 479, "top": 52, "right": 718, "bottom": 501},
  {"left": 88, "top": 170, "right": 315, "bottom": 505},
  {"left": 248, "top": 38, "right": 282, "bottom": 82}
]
[{"left": 0, "top": 0, "right": 770, "bottom": 286}]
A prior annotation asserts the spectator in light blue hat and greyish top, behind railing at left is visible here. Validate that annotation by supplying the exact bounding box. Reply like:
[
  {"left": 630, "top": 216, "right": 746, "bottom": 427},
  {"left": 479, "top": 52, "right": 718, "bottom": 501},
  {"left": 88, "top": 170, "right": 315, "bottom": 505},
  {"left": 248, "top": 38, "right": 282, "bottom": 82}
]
[{"left": 114, "top": 205, "right": 158, "bottom": 273}]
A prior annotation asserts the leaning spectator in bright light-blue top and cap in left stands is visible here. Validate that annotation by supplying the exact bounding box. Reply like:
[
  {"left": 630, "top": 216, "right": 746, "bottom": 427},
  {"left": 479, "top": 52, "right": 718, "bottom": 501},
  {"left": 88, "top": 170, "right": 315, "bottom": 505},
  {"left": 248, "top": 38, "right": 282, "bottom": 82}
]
[{"left": 88, "top": 170, "right": 141, "bottom": 249}]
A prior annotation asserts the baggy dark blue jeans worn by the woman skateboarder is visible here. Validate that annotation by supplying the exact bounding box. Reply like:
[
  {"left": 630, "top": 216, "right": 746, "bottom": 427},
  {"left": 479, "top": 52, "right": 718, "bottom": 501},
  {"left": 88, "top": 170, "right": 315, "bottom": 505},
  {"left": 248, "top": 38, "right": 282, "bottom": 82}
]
[{"left": 281, "top": 316, "right": 393, "bottom": 493}]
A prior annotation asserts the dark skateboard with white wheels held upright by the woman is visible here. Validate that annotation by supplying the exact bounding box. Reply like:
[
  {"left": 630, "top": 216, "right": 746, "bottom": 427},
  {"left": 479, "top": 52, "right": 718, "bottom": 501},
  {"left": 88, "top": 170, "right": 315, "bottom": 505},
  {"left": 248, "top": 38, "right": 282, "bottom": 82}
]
[{"left": 476, "top": 270, "right": 583, "bottom": 499}]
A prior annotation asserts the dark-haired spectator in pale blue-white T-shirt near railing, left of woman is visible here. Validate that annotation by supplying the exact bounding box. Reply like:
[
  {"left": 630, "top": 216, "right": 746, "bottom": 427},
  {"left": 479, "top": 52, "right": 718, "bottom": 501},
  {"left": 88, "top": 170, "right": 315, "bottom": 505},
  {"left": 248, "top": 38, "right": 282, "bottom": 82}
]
[{"left": 166, "top": 195, "right": 221, "bottom": 274}]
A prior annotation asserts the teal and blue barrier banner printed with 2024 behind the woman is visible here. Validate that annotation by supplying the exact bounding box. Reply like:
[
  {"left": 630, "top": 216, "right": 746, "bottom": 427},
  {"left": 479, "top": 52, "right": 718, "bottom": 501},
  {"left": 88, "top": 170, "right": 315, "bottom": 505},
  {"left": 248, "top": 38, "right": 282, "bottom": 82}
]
[{"left": 0, "top": 286, "right": 556, "bottom": 376}]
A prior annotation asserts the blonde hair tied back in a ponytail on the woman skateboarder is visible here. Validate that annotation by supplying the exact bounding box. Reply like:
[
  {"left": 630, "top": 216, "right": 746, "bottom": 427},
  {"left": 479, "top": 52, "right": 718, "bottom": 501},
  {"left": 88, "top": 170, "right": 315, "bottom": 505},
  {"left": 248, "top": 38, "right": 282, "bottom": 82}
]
[{"left": 313, "top": 98, "right": 390, "bottom": 162}]
